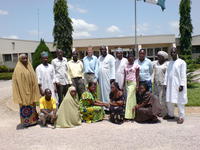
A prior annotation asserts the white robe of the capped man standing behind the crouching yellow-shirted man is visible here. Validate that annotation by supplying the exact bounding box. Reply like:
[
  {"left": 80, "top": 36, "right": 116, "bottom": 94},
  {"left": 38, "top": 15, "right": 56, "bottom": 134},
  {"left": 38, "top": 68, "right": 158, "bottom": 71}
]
[{"left": 36, "top": 64, "right": 57, "bottom": 99}]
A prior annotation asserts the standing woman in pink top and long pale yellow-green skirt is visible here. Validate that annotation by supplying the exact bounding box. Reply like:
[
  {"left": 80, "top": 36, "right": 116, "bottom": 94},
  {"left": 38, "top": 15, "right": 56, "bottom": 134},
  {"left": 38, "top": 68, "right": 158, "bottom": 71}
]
[{"left": 125, "top": 54, "right": 139, "bottom": 120}]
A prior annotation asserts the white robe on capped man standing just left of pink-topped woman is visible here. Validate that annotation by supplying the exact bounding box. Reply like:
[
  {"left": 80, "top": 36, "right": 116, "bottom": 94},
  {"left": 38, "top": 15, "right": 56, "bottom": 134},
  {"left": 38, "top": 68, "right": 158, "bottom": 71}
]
[{"left": 115, "top": 58, "right": 128, "bottom": 89}]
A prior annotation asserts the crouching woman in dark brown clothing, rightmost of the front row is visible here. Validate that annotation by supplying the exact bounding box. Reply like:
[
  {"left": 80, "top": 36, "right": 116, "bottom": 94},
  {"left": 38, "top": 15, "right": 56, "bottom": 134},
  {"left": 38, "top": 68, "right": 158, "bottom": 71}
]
[{"left": 133, "top": 83, "right": 161, "bottom": 123}]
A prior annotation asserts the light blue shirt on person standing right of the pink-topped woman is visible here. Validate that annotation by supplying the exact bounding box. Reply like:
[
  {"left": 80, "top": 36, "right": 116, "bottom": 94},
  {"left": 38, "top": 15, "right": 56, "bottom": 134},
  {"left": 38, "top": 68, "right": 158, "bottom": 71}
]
[{"left": 135, "top": 58, "right": 153, "bottom": 81}]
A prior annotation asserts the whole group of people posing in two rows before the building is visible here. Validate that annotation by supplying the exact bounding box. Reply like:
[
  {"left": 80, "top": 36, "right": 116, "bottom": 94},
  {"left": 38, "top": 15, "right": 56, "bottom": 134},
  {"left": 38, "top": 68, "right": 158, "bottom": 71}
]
[{"left": 12, "top": 46, "right": 187, "bottom": 128}]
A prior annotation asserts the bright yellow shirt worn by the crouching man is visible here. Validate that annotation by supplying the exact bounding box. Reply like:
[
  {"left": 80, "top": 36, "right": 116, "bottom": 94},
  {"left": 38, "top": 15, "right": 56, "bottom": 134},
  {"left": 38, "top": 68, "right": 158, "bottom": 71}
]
[{"left": 40, "top": 96, "right": 56, "bottom": 110}]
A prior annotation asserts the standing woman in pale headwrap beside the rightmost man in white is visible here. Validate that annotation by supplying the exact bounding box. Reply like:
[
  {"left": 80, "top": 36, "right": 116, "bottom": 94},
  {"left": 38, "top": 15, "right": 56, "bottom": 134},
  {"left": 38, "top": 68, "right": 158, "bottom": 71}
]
[{"left": 153, "top": 51, "right": 168, "bottom": 117}]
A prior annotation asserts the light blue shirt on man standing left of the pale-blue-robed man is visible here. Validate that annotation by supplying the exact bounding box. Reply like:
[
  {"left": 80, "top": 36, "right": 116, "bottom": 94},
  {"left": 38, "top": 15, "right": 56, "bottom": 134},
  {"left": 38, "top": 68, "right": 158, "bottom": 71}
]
[{"left": 83, "top": 55, "right": 98, "bottom": 78}]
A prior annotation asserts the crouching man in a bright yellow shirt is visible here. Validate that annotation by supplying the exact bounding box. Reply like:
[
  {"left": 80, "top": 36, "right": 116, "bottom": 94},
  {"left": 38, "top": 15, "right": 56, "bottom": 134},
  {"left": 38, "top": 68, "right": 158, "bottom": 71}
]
[{"left": 39, "top": 89, "right": 56, "bottom": 126}]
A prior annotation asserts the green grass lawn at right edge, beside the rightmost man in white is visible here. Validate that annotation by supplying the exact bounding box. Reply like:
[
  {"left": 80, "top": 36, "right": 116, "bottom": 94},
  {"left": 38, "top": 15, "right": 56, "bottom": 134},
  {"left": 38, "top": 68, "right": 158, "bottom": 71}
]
[{"left": 187, "top": 83, "right": 200, "bottom": 106}]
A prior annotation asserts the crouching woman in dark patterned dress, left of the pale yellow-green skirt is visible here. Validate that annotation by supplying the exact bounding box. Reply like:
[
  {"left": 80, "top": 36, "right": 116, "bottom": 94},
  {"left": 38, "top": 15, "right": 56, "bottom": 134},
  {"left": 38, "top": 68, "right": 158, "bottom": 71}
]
[{"left": 110, "top": 82, "right": 125, "bottom": 124}]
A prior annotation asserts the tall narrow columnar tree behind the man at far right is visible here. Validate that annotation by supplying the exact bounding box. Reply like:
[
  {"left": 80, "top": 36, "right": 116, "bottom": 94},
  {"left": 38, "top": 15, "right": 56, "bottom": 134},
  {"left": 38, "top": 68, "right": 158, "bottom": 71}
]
[{"left": 179, "top": 0, "right": 193, "bottom": 59}]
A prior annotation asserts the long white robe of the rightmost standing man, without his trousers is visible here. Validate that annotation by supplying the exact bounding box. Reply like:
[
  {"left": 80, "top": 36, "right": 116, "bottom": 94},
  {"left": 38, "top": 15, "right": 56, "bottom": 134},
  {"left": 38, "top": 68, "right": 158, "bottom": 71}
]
[{"left": 164, "top": 58, "right": 188, "bottom": 104}]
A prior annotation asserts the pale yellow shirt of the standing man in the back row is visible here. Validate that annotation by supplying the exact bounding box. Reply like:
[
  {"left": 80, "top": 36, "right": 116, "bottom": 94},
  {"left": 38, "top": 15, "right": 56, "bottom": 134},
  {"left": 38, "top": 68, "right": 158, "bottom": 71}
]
[{"left": 68, "top": 60, "right": 83, "bottom": 79}]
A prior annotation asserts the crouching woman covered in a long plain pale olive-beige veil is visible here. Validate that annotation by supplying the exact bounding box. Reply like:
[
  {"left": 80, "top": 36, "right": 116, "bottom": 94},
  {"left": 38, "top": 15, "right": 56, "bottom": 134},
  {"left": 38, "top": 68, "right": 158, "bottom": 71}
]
[{"left": 56, "top": 86, "right": 81, "bottom": 128}]
